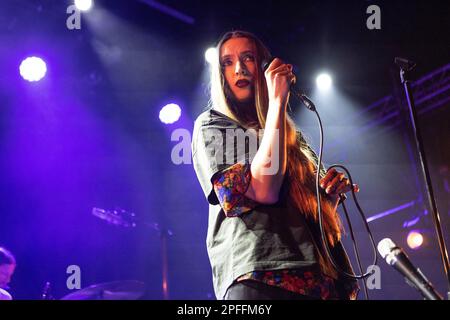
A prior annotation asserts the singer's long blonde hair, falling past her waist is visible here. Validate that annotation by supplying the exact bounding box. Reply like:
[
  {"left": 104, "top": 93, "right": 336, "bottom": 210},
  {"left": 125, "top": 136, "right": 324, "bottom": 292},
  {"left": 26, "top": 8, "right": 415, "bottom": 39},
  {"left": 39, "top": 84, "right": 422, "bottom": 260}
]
[{"left": 210, "top": 31, "right": 342, "bottom": 272}]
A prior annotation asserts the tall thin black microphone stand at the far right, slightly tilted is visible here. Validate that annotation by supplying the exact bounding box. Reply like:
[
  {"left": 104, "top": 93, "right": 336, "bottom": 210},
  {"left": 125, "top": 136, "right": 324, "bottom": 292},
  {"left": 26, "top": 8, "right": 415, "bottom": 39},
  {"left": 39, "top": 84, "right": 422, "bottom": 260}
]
[{"left": 395, "top": 58, "right": 450, "bottom": 300}]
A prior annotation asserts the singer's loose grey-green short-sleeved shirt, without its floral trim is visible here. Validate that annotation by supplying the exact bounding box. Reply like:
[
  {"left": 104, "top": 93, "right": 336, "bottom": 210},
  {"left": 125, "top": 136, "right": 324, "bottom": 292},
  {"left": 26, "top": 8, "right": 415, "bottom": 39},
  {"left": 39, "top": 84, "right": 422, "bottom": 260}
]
[{"left": 192, "top": 109, "right": 356, "bottom": 299}]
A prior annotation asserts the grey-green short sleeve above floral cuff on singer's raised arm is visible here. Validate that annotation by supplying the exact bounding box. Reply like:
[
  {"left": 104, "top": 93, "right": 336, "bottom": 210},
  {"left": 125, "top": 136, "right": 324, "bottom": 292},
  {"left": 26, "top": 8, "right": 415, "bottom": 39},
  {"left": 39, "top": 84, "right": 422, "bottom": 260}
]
[{"left": 192, "top": 111, "right": 257, "bottom": 205}]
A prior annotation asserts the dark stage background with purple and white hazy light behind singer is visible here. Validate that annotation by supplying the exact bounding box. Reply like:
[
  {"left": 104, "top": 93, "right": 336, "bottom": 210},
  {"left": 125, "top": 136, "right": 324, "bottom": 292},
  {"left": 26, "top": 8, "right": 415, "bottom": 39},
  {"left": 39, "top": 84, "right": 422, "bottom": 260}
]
[{"left": 0, "top": 0, "right": 450, "bottom": 299}]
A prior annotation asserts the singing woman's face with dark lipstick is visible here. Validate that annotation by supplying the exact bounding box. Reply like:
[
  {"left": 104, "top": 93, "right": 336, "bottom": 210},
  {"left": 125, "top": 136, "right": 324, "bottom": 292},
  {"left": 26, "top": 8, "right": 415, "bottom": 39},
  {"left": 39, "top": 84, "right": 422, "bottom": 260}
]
[{"left": 220, "top": 38, "right": 256, "bottom": 102}]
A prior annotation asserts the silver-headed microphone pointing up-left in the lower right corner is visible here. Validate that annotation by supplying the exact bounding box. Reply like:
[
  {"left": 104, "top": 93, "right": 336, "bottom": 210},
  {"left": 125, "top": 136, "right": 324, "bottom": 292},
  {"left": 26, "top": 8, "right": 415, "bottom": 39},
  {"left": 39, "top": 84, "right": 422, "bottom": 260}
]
[{"left": 378, "top": 238, "right": 443, "bottom": 300}]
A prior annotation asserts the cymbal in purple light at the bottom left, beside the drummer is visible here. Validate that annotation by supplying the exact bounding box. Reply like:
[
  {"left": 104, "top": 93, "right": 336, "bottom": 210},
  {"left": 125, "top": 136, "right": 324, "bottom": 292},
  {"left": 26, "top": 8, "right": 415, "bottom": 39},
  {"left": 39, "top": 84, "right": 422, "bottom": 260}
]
[{"left": 61, "top": 280, "right": 145, "bottom": 300}]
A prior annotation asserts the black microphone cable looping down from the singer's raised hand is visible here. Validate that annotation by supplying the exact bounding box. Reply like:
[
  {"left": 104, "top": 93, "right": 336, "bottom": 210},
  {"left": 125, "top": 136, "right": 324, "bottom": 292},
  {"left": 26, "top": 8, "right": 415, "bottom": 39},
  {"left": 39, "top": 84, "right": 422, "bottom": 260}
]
[{"left": 307, "top": 107, "right": 378, "bottom": 298}]
